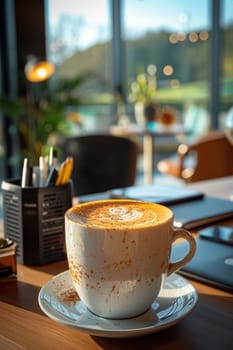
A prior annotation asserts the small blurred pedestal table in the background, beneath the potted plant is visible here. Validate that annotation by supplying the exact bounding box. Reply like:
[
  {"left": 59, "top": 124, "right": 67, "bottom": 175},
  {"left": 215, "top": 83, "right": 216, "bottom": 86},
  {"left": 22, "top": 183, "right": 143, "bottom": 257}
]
[{"left": 110, "top": 124, "right": 185, "bottom": 184}]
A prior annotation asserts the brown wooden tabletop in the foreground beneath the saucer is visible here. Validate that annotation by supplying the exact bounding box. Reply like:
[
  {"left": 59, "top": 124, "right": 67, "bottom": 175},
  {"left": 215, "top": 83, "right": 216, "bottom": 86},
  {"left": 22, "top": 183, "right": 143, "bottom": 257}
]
[{"left": 0, "top": 177, "right": 233, "bottom": 350}]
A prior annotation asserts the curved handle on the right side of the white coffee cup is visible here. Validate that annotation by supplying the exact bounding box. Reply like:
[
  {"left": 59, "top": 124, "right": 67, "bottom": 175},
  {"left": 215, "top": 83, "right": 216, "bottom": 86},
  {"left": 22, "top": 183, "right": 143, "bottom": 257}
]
[{"left": 167, "top": 229, "right": 196, "bottom": 276}]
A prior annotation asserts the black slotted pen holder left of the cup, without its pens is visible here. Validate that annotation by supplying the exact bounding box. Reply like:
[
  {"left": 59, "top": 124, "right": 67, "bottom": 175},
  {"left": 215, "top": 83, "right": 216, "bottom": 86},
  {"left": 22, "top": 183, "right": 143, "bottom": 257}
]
[{"left": 2, "top": 179, "right": 73, "bottom": 266}]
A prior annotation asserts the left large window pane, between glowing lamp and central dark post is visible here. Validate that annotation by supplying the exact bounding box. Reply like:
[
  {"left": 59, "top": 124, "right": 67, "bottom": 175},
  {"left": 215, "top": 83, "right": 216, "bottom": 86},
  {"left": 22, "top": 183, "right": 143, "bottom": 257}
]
[{"left": 47, "top": 0, "right": 113, "bottom": 130}]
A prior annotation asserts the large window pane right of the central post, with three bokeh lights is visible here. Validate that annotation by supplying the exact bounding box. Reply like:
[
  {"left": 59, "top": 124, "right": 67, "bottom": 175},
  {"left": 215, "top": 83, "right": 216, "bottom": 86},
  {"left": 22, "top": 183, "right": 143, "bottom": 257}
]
[{"left": 123, "top": 0, "right": 211, "bottom": 133}]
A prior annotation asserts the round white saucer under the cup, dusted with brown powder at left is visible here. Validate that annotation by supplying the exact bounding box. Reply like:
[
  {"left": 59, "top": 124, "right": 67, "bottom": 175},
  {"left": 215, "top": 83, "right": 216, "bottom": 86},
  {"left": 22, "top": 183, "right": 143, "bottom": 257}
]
[{"left": 38, "top": 271, "right": 198, "bottom": 338}]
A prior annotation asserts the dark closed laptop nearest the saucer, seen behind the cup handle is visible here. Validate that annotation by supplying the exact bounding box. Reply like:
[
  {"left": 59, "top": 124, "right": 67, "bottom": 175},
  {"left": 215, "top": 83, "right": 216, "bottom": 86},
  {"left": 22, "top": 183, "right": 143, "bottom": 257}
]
[{"left": 171, "top": 238, "right": 233, "bottom": 293}]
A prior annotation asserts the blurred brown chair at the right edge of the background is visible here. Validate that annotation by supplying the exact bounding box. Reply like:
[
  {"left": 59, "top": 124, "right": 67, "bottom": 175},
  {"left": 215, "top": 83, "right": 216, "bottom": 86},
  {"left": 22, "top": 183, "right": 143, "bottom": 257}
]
[{"left": 157, "top": 130, "right": 233, "bottom": 182}]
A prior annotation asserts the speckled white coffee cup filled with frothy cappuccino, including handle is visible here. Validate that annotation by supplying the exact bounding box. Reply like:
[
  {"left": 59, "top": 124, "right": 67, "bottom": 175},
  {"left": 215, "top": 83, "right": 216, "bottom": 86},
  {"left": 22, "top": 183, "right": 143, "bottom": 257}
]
[{"left": 65, "top": 200, "right": 196, "bottom": 319}]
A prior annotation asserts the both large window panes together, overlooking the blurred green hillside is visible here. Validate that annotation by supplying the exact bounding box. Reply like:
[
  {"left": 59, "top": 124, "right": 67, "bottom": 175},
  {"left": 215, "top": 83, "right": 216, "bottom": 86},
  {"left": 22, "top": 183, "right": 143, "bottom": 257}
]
[{"left": 48, "top": 0, "right": 218, "bottom": 133}]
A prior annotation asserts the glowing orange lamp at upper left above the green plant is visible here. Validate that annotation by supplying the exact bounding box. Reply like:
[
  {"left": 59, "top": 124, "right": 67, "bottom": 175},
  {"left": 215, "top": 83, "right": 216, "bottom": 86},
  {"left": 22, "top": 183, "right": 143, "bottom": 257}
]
[{"left": 24, "top": 56, "right": 55, "bottom": 83}]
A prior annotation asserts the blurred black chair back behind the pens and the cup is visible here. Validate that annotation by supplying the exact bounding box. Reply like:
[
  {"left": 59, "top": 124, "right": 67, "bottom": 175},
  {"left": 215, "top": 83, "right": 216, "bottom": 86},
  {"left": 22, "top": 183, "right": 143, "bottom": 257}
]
[{"left": 62, "top": 135, "right": 138, "bottom": 196}]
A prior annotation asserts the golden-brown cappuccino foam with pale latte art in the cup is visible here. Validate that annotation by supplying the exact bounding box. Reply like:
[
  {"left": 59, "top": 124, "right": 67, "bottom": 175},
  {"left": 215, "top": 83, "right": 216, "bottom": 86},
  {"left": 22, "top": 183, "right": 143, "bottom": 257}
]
[{"left": 67, "top": 200, "right": 173, "bottom": 229}]
